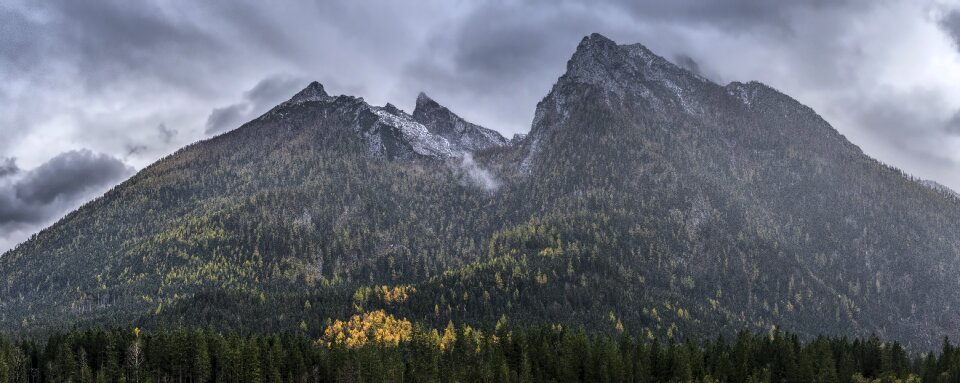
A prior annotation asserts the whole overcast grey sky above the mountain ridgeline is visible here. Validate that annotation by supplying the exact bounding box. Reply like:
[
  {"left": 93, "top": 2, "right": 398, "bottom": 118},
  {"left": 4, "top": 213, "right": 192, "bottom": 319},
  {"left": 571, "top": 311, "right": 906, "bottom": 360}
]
[{"left": 0, "top": 0, "right": 960, "bottom": 251}]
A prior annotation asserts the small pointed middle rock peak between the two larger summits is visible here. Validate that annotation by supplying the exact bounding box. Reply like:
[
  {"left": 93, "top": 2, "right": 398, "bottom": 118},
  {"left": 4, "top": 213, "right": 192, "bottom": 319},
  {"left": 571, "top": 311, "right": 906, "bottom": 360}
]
[{"left": 413, "top": 93, "right": 508, "bottom": 152}]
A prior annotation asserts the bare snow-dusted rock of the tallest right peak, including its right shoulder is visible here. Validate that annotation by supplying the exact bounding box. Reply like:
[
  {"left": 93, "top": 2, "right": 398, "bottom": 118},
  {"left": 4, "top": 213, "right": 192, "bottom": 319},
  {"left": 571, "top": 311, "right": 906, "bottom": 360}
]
[{"left": 521, "top": 34, "right": 862, "bottom": 171}]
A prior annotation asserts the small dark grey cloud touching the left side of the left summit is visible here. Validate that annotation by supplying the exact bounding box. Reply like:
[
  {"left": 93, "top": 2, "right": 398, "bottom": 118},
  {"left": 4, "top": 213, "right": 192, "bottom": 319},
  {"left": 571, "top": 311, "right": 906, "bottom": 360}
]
[{"left": 205, "top": 76, "right": 306, "bottom": 134}]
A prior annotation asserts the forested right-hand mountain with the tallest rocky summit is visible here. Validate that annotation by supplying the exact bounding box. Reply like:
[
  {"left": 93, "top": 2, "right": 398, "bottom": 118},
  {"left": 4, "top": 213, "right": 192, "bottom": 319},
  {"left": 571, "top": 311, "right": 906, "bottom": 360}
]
[{"left": 502, "top": 35, "right": 960, "bottom": 348}]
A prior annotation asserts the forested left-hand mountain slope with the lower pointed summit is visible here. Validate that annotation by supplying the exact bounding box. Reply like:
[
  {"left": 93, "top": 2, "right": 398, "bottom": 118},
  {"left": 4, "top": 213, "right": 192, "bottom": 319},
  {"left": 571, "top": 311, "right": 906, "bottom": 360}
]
[{"left": 0, "top": 83, "right": 506, "bottom": 329}]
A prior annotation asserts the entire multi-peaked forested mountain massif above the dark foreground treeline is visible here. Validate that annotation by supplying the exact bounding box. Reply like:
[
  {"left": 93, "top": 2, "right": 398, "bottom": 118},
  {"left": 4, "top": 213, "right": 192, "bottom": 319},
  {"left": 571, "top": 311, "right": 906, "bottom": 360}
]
[{"left": 0, "top": 34, "right": 960, "bottom": 349}]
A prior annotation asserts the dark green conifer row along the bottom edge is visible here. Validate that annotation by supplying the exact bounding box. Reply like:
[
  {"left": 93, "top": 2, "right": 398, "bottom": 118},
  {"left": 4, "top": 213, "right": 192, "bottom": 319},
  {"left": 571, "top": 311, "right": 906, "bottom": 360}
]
[{"left": 0, "top": 326, "right": 960, "bottom": 383}]
